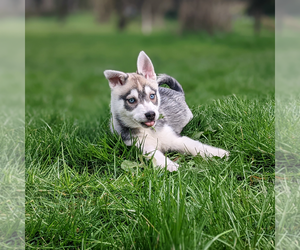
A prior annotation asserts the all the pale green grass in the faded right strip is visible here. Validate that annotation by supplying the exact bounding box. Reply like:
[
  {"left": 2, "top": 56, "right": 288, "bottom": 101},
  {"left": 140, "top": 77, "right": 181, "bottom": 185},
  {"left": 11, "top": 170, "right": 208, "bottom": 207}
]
[{"left": 275, "top": 31, "right": 300, "bottom": 249}]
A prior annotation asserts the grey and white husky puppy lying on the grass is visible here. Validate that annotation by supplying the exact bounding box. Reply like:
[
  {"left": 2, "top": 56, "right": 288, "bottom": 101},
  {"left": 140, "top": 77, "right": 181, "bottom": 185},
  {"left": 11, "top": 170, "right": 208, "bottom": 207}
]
[{"left": 104, "top": 51, "right": 229, "bottom": 172}]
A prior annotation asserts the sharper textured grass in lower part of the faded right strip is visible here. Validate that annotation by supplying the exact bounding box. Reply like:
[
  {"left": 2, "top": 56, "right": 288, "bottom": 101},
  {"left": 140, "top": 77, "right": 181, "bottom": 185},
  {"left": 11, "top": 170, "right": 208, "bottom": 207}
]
[{"left": 275, "top": 96, "right": 300, "bottom": 249}]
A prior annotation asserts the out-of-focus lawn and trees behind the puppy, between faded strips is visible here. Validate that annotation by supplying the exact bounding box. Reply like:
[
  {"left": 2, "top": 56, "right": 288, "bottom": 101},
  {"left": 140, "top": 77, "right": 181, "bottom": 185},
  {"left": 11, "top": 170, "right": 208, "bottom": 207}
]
[{"left": 21, "top": 0, "right": 275, "bottom": 119}]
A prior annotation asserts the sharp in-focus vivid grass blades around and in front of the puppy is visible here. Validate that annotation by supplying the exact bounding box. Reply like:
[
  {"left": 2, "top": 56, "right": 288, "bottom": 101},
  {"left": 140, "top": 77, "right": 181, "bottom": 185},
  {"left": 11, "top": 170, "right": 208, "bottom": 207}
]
[{"left": 26, "top": 97, "right": 275, "bottom": 249}]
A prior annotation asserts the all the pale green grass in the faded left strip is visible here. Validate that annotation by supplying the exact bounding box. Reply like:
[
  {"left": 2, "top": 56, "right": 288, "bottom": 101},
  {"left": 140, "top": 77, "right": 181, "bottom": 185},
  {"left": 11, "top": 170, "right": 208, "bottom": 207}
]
[{"left": 0, "top": 18, "right": 25, "bottom": 249}]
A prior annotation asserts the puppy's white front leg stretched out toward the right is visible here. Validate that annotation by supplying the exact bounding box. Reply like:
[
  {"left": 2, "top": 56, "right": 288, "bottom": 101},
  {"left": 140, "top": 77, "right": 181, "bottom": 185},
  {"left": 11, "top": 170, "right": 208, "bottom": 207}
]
[{"left": 173, "top": 136, "right": 229, "bottom": 158}]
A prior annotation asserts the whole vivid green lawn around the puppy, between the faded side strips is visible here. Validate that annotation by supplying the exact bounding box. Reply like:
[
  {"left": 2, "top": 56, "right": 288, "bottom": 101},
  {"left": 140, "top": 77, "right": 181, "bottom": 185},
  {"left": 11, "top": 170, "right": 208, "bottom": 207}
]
[{"left": 26, "top": 14, "right": 275, "bottom": 249}]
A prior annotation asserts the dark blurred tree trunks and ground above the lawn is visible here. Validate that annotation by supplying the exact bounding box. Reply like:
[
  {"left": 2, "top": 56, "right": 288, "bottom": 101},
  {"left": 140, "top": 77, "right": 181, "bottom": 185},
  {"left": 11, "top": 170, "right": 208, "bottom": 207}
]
[{"left": 22, "top": 0, "right": 275, "bottom": 34}]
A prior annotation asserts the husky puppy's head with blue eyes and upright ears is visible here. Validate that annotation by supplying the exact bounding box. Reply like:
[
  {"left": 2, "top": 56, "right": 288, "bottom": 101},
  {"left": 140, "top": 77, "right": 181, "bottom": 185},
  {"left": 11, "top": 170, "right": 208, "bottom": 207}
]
[{"left": 104, "top": 51, "right": 160, "bottom": 128}]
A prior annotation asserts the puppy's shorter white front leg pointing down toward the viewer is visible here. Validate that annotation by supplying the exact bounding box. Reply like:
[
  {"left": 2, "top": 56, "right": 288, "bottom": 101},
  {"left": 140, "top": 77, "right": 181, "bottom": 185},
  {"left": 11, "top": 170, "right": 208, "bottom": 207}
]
[{"left": 143, "top": 145, "right": 179, "bottom": 172}]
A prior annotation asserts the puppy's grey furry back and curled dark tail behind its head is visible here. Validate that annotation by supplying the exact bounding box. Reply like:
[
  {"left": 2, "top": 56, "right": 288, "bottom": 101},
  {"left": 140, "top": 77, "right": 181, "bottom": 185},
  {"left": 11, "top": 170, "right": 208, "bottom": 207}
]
[{"left": 156, "top": 74, "right": 193, "bottom": 134}]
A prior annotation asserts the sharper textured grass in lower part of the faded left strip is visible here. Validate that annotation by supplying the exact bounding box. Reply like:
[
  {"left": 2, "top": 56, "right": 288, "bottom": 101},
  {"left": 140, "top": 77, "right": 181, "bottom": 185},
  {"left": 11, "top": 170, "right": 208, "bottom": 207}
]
[{"left": 0, "top": 113, "right": 25, "bottom": 249}]
